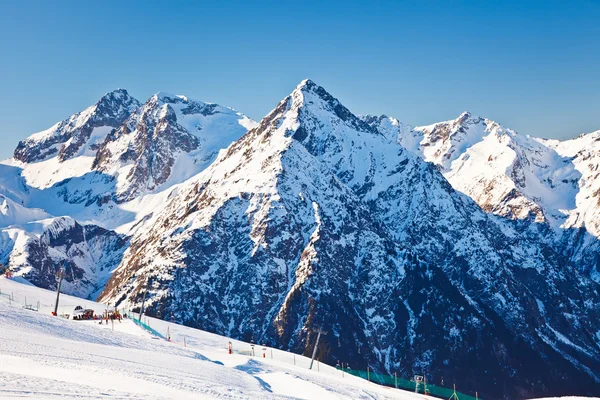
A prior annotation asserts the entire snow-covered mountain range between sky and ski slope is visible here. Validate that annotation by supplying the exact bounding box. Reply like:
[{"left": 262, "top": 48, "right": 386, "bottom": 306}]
[{"left": 0, "top": 80, "right": 600, "bottom": 399}]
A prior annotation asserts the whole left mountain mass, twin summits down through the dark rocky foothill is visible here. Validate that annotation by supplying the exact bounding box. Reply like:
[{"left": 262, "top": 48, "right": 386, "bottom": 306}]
[{"left": 0, "top": 89, "right": 254, "bottom": 297}]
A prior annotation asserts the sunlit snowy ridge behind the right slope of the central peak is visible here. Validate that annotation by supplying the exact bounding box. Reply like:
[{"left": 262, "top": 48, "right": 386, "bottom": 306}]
[{"left": 365, "top": 112, "right": 600, "bottom": 282}]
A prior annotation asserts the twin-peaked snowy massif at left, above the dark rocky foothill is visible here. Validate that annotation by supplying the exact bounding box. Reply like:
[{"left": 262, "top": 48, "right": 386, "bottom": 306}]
[{"left": 0, "top": 89, "right": 255, "bottom": 225}]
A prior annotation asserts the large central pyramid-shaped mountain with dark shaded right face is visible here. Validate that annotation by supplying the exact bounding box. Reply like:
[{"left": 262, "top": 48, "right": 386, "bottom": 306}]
[{"left": 95, "top": 81, "right": 599, "bottom": 398}]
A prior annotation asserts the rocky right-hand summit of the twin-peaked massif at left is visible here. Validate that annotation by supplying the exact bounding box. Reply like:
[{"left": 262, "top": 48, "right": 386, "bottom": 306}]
[{"left": 93, "top": 93, "right": 254, "bottom": 201}]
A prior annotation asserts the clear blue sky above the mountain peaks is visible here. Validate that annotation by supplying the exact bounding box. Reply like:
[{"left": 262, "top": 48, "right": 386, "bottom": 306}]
[{"left": 0, "top": 0, "right": 600, "bottom": 158}]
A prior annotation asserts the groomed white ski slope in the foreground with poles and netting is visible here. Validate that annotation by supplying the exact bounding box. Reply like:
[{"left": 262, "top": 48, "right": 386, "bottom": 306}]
[{"left": 0, "top": 277, "right": 426, "bottom": 399}]
